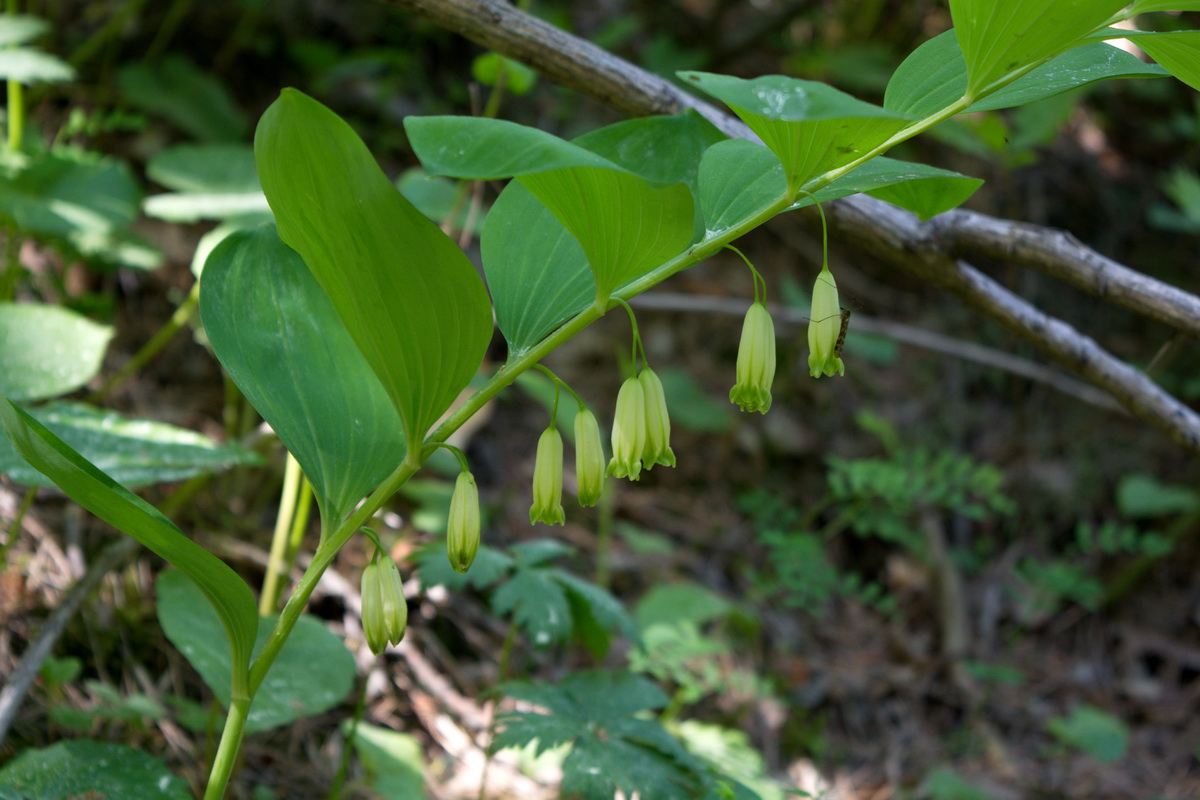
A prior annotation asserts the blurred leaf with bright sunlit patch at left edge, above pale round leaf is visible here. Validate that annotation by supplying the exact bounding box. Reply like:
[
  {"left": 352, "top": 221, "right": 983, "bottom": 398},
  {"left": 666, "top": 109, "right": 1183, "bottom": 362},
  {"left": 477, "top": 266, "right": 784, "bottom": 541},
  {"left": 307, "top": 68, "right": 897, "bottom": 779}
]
[{"left": 0, "top": 154, "right": 140, "bottom": 255}]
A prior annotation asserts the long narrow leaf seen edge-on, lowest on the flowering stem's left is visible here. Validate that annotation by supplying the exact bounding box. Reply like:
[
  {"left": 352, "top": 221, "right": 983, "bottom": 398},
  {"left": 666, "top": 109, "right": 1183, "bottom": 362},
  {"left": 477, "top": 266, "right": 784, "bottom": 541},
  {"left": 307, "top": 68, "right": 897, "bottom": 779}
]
[{"left": 0, "top": 397, "right": 258, "bottom": 684}]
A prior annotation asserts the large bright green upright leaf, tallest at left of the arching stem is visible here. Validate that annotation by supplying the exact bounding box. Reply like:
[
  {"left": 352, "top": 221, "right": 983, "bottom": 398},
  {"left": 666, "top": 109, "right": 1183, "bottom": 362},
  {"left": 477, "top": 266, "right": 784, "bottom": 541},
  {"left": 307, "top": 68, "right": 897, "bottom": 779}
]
[{"left": 254, "top": 89, "right": 492, "bottom": 447}]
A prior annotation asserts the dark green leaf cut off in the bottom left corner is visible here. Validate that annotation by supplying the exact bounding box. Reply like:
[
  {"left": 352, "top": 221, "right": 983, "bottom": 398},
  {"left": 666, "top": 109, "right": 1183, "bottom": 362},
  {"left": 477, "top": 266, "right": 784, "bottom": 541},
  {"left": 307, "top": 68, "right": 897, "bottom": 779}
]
[{"left": 0, "top": 739, "right": 192, "bottom": 800}]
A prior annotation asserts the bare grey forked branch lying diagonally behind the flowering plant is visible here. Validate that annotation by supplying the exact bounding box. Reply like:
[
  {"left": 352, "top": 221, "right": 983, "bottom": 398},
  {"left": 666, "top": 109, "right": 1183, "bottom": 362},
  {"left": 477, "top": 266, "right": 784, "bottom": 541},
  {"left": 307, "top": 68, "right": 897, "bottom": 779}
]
[{"left": 380, "top": 0, "right": 1200, "bottom": 451}]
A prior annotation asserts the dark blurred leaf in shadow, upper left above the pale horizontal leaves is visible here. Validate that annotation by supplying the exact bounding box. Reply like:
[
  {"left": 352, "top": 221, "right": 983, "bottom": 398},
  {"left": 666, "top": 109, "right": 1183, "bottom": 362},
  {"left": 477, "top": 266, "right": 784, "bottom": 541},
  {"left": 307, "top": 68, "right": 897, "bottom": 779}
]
[{"left": 116, "top": 55, "right": 247, "bottom": 142}]
